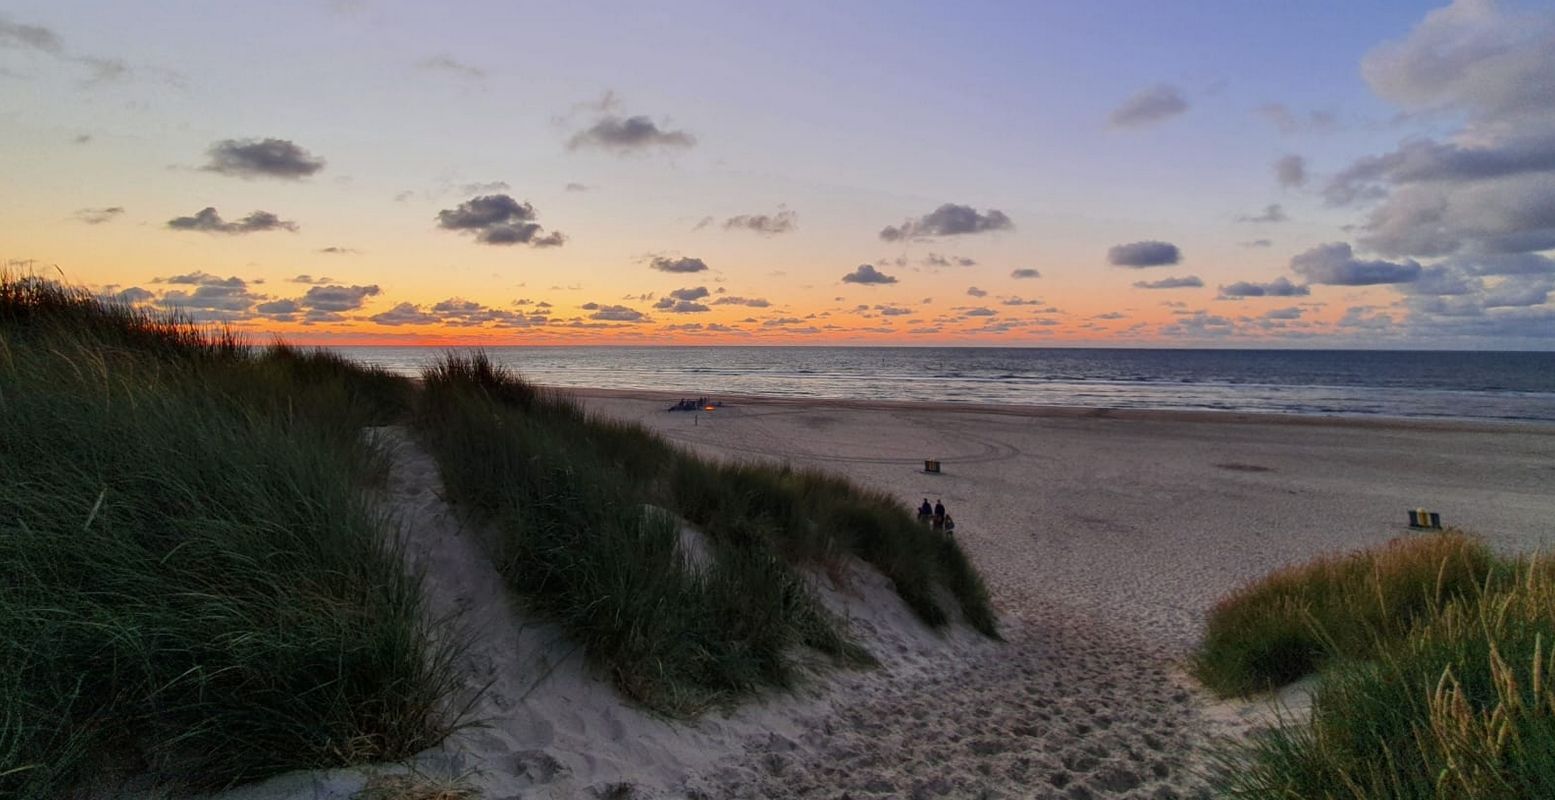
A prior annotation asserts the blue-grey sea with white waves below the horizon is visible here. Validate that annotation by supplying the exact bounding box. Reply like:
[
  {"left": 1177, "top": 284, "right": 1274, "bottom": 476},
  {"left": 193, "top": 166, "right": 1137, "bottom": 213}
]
[{"left": 336, "top": 347, "right": 1555, "bottom": 422}]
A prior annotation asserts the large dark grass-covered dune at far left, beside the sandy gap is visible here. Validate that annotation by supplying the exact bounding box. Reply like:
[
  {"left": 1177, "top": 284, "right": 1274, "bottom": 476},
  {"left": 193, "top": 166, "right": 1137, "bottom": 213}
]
[{"left": 0, "top": 277, "right": 454, "bottom": 798}]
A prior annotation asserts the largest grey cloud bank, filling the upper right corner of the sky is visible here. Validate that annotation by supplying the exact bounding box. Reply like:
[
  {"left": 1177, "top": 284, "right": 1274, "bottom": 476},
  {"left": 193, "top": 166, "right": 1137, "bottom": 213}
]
[{"left": 1323, "top": 0, "right": 1555, "bottom": 257}]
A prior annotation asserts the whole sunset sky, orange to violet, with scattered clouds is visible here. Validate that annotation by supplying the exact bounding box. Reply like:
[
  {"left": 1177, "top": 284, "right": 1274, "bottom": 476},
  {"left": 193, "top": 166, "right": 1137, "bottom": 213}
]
[{"left": 0, "top": 0, "right": 1555, "bottom": 350}]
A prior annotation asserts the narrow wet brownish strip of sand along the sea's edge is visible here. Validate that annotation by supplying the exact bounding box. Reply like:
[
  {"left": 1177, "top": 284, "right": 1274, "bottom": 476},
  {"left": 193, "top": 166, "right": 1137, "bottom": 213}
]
[{"left": 556, "top": 384, "right": 1555, "bottom": 436}]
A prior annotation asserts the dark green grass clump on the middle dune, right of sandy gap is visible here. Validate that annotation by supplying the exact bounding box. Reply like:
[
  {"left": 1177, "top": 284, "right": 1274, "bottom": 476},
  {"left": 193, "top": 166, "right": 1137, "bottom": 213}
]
[{"left": 417, "top": 355, "right": 995, "bottom": 714}]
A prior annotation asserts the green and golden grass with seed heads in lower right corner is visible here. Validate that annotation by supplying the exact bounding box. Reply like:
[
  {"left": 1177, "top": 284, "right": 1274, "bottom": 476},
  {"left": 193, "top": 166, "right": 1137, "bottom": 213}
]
[{"left": 1194, "top": 532, "right": 1555, "bottom": 800}]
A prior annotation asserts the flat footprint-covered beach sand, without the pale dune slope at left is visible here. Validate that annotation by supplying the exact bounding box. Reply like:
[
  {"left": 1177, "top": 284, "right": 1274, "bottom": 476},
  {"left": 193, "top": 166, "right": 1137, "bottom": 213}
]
[{"left": 559, "top": 392, "right": 1555, "bottom": 798}]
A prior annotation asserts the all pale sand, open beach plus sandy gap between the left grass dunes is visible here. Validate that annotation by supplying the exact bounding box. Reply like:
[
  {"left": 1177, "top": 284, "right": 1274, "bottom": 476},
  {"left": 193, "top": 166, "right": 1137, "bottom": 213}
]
[{"left": 209, "top": 391, "right": 1555, "bottom": 800}]
